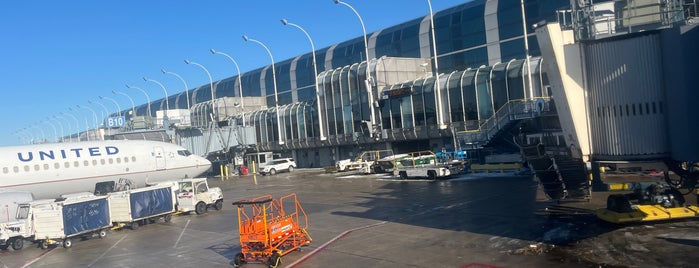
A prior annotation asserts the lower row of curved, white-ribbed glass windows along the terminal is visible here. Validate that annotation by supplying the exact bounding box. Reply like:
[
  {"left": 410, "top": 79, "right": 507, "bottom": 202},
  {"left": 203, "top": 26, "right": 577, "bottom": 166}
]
[{"left": 232, "top": 57, "right": 549, "bottom": 148}]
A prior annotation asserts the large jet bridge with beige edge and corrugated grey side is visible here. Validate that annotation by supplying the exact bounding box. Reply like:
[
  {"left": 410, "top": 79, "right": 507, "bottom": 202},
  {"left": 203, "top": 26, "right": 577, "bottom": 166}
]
[{"left": 524, "top": 0, "right": 699, "bottom": 199}]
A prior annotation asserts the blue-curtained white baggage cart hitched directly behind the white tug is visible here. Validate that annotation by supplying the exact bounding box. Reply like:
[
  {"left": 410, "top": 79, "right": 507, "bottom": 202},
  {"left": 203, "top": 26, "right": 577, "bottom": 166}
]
[{"left": 107, "top": 184, "right": 178, "bottom": 230}]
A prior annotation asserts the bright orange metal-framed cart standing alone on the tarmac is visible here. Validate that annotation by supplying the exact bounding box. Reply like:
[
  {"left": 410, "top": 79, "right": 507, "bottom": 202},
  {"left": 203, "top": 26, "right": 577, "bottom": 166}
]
[{"left": 233, "top": 194, "right": 313, "bottom": 267}]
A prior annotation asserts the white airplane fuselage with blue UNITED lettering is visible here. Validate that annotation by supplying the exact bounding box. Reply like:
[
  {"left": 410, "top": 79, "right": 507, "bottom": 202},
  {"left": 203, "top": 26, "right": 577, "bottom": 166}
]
[{"left": 0, "top": 140, "right": 211, "bottom": 198}]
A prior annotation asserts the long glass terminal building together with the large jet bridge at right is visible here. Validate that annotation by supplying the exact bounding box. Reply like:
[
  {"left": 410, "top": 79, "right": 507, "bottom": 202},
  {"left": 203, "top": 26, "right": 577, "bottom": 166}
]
[{"left": 100, "top": 0, "right": 699, "bottom": 183}]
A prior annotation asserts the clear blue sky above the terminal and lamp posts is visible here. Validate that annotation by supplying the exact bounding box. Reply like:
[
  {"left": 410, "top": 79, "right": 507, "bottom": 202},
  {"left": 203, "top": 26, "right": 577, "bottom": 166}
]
[{"left": 0, "top": 0, "right": 468, "bottom": 146}]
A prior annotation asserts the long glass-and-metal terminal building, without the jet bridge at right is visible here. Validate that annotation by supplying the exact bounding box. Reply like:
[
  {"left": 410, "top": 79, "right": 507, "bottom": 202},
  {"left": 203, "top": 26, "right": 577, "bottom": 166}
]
[{"left": 110, "top": 0, "right": 568, "bottom": 167}]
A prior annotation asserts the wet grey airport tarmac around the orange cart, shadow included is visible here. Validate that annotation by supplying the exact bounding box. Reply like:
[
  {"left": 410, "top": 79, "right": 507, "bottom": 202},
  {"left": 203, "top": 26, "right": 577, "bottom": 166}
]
[{"left": 0, "top": 169, "right": 699, "bottom": 268}]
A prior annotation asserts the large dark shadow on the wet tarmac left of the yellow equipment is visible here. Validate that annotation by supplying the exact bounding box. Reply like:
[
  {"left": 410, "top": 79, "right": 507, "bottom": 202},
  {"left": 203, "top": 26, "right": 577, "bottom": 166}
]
[{"left": 334, "top": 177, "right": 618, "bottom": 245}]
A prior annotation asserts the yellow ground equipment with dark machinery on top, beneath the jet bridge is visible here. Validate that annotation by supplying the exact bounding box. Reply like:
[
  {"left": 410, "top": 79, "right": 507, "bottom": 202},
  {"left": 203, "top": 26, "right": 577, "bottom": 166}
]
[{"left": 595, "top": 183, "right": 699, "bottom": 224}]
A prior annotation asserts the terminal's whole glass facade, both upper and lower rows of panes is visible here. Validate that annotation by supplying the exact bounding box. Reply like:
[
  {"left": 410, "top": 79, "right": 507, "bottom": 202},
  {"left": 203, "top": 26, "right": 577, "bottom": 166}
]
[{"left": 130, "top": 0, "right": 568, "bottom": 148}]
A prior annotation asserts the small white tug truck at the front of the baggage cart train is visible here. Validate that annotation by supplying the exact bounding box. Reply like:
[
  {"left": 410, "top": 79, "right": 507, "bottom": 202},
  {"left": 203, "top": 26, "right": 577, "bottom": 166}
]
[{"left": 177, "top": 178, "right": 223, "bottom": 214}]
